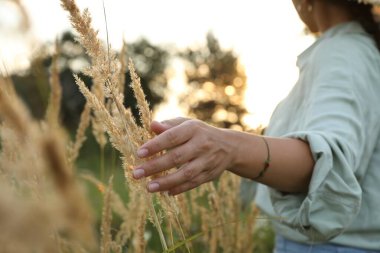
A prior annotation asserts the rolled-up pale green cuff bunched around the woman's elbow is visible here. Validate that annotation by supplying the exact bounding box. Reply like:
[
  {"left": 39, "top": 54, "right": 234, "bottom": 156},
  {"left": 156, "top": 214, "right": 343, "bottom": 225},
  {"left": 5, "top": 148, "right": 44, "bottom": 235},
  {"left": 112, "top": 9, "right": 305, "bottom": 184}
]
[{"left": 270, "top": 132, "right": 362, "bottom": 242}]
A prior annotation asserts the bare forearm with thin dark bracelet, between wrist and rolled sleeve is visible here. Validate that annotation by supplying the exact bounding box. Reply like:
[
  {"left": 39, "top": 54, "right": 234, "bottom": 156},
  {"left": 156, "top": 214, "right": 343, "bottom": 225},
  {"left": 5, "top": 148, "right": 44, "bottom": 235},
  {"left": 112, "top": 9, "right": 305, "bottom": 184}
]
[{"left": 226, "top": 130, "right": 314, "bottom": 192}]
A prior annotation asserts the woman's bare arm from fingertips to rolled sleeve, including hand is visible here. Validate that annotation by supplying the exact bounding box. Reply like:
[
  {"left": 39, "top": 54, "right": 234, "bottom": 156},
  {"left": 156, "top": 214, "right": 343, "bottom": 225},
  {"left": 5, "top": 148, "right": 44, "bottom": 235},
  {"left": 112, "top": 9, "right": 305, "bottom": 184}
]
[{"left": 137, "top": 118, "right": 314, "bottom": 195}]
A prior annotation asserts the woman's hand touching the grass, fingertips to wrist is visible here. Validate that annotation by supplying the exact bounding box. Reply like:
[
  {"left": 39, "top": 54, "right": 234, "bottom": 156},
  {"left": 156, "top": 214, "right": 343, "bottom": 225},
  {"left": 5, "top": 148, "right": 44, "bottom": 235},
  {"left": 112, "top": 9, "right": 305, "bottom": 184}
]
[{"left": 133, "top": 118, "right": 236, "bottom": 195}]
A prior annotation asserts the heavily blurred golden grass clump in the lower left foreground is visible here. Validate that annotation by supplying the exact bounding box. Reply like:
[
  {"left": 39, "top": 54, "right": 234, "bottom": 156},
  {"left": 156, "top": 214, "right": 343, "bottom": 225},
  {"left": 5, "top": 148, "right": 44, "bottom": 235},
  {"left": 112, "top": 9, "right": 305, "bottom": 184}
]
[{"left": 0, "top": 76, "right": 96, "bottom": 252}]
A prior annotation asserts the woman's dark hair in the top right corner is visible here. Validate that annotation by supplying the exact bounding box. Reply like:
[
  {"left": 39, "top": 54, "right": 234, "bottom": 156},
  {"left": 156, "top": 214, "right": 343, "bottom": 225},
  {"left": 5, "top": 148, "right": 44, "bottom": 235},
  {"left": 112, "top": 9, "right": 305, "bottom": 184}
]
[{"left": 327, "top": 0, "right": 380, "bottom": 51}]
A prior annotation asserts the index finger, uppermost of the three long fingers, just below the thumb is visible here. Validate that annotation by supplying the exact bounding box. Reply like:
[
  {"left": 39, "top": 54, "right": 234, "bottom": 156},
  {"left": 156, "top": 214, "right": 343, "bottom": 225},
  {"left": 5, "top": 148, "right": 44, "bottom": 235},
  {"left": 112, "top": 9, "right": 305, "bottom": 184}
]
[{"left": 137, "top": 120, "right": 192, "bottom": 158}]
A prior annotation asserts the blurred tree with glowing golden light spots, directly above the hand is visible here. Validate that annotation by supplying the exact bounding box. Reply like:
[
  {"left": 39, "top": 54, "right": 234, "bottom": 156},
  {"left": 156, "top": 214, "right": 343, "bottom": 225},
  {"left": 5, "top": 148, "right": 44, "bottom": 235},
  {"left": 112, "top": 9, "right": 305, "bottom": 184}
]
[{"left": 180, "top": 33, "right": 247, "bottom": 129}]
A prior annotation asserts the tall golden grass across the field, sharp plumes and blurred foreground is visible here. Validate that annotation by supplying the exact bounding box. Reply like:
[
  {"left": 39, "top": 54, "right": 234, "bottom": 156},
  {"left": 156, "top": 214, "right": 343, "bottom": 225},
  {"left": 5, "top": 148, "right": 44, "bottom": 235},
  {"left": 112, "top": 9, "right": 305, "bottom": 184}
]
[{"left": 0, "top": 0, "right": 272, "bottom": 253}]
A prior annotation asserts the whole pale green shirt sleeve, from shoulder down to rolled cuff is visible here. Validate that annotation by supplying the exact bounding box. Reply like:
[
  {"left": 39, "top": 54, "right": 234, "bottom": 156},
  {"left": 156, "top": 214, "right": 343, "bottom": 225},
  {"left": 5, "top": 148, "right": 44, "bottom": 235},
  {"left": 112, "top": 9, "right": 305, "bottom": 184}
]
[{"left": 270, "top": 37, "right": 373, "bottom": 242}]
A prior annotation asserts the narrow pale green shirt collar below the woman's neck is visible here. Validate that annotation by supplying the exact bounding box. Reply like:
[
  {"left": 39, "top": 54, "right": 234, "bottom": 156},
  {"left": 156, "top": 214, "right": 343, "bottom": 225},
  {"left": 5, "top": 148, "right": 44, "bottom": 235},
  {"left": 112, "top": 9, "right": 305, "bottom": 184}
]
[{"left": 297, "top": 21, "right": 366, "bottom": 68}]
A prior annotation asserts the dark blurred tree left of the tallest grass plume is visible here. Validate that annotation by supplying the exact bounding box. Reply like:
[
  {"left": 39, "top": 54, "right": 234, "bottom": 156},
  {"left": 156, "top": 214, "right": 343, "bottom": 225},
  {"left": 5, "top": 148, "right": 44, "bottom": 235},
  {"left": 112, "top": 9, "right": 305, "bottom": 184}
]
[{"left": 12, "top": 32, "right": 91, "bottom": 129}]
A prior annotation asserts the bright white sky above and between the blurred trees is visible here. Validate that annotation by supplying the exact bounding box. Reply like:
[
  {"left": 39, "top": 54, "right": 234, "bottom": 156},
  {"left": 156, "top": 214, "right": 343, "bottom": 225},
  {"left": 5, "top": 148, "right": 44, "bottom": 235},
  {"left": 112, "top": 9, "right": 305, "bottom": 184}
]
[{"left": 0, "top": 0, "right": 313, "bottom": 126}]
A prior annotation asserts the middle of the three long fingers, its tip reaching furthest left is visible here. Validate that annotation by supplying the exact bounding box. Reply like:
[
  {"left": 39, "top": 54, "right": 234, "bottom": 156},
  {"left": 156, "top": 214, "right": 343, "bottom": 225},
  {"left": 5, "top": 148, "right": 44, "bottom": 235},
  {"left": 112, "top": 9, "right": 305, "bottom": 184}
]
[{"left": 133, "top": 142, "right": 195, "bottom": 179}]
